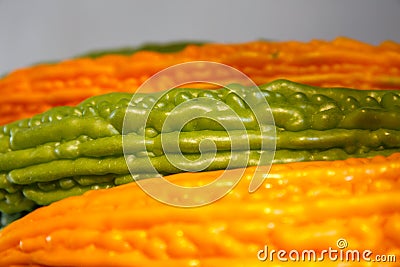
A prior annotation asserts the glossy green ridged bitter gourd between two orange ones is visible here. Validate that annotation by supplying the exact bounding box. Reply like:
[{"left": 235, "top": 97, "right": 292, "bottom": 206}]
[{"left": 0, "top": 80, "right": 400, "bottom": 228}]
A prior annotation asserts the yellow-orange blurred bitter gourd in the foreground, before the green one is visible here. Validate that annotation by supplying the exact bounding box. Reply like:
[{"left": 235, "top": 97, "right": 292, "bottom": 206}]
[{"left": 0, "top": 153, "right": 400, "bottom": 266}]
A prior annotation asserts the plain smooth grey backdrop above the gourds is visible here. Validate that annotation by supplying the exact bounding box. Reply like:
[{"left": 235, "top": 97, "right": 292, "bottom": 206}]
[{"left": 0, "top": 0, "right": 400, "bottom": 74}]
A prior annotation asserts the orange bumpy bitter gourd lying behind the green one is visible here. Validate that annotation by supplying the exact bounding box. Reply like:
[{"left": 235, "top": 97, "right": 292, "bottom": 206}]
[{"left": 0, "top": 38, "right": 400, "bottom": 125}]
